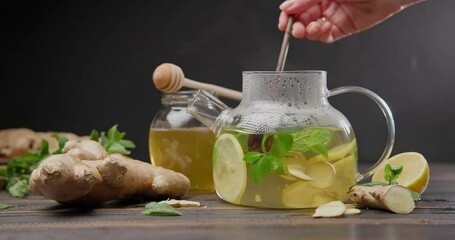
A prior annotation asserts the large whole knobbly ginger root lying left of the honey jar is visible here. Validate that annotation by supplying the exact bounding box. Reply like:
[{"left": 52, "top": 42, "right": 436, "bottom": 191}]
[{"left": 29, "top": 140, "right": 190, "bottom": 205}]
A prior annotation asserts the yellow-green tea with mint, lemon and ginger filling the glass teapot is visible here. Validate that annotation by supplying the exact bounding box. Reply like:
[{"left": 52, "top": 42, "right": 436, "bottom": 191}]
[{"left": 214, "top": 127, "right": 357, "bottom": 208}]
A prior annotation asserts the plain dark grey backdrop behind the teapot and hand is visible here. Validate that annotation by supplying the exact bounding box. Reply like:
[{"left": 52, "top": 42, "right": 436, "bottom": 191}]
[{"left": 0, "top": 0, "right": 455, "bottom": 165}]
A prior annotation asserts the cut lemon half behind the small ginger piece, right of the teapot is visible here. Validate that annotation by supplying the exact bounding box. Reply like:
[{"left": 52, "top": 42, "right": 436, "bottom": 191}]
[{"left": 372, "top": 152, "right": 430, "bottom": 194}]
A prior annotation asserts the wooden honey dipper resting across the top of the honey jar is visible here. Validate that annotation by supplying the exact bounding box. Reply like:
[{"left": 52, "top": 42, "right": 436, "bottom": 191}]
[{"left": 152, "top": 63, "right": 242, "bottom": 101}]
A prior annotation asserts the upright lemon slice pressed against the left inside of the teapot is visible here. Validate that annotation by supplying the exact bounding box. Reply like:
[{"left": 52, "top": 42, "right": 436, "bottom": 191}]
[{"left": 213, "top": 133, "right": 247, "bottom": 204}]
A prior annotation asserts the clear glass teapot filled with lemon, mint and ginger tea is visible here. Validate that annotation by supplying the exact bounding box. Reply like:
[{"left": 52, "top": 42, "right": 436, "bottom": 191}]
[{"left": 188, "top": 71, "right": 395, "bottom": 208}]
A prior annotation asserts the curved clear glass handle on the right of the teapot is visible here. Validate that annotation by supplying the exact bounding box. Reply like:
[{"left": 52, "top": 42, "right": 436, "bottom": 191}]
[{"left": 329, "top": 86, "right": 395, "bottom": 182}]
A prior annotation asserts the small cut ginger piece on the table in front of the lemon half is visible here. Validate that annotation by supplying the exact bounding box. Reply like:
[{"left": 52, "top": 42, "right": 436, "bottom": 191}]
[{"left": 349, "top": 185, "right": 415, "bottom": 214}]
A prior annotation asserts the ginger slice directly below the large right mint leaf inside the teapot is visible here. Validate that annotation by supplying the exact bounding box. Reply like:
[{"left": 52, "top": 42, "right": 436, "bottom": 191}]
[{"left": 305, "top": 162, "right": 336, "bottom": 188}]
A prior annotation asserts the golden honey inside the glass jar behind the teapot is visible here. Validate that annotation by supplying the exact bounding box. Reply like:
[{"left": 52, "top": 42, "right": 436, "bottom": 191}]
[{"left": 149, "top": 128, "right": 215, "bottom": 193}]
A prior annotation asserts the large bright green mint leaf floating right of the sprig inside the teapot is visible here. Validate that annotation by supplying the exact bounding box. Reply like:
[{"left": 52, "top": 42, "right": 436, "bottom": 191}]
[{"left": 292, "top": 127, "right": 334, "bottom": 157}]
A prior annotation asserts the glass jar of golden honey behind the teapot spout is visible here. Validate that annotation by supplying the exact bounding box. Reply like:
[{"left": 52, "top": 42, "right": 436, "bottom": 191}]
[{"left": 149, "top": 90, "right": 215, "bottom": 193}]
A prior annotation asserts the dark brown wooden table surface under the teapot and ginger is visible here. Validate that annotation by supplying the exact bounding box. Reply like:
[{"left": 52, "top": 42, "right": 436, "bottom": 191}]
[{"left": 0, "top": 164, "right": 455, "bottom": 240}]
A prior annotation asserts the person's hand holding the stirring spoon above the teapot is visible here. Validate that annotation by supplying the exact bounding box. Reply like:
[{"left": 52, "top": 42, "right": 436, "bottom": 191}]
[{"left": 278, "top": 0, "right": 422, "bottom": 43}]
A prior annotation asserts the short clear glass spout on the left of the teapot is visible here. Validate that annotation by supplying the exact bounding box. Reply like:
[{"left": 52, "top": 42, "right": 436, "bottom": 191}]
[{"left": 187, "top": 90, "right": 231, "bottom": 135}]
